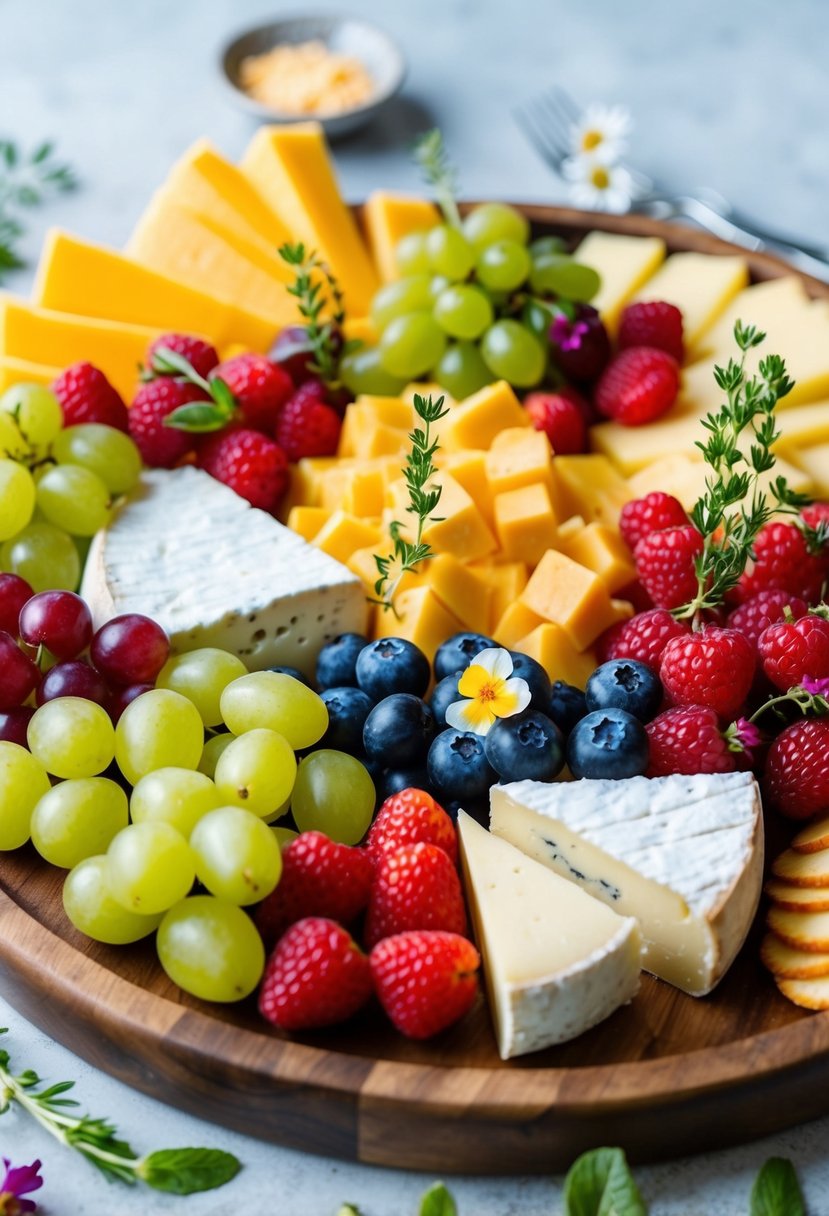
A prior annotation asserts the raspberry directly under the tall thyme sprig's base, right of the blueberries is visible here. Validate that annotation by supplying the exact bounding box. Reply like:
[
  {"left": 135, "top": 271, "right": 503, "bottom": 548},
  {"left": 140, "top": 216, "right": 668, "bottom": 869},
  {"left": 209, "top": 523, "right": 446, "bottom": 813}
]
[{"left": 659, "top": 625, "right": 756, "bottom": 717}]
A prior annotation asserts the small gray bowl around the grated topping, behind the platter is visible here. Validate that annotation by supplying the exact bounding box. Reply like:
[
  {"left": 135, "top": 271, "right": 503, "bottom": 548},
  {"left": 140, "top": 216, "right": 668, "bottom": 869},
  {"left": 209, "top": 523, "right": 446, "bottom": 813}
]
[{"left": 221, "top": 13, "right": 406, "bottom": 139}]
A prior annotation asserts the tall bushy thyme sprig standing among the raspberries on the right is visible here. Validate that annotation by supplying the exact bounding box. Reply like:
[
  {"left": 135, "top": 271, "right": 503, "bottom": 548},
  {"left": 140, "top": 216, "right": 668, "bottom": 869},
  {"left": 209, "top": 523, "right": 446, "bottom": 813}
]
[{"left": 675, "top": 321, "right": 810, "bottom": 621}]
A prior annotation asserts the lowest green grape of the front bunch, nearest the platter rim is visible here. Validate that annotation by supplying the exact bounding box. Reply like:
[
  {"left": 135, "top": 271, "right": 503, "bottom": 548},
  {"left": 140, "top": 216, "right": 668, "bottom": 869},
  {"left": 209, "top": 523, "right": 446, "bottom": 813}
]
[{"left": 156, "top": 895, "right": 265, "bottom": 1002}]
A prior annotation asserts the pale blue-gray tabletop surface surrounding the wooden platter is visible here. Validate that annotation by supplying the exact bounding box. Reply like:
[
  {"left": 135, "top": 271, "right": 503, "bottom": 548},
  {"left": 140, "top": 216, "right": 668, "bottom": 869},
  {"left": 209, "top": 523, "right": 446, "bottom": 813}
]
[{"left": 0, "top": 0, "right": 829, "bottom": 1216}]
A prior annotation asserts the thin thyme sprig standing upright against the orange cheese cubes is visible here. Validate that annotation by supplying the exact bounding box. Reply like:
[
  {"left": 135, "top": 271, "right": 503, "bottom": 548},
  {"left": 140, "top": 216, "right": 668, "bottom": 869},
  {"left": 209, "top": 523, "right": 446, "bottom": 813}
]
[{"left": 371, "top": 393, "right": 449, "bottom": 614}]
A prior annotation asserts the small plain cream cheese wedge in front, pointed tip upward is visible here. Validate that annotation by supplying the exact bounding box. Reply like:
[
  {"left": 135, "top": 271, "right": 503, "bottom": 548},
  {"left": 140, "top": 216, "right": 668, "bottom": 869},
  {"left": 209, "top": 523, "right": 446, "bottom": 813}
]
[{"left": 458, "top": 811, "right": 642, "bottom": 1059}]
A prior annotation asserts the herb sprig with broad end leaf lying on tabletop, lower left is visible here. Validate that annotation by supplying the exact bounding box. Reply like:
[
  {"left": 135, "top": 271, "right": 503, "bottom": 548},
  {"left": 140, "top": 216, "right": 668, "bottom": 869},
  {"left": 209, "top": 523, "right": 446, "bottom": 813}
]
[{"left": 0, "top": 1029, "right": 242, "bottom": 1195}]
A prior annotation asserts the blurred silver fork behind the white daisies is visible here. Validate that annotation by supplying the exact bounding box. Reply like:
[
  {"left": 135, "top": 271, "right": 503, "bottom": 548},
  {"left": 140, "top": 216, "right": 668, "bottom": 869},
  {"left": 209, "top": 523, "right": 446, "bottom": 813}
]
[{"left": 514, "top": 86, "right": 829, "bottom": 281}]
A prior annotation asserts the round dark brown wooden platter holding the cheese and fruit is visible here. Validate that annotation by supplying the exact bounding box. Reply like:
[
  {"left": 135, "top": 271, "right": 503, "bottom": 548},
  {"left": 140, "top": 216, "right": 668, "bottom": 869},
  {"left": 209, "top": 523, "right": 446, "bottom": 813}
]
[{"left": 0, "top": 207, "right": 829, "bottom": 1173}]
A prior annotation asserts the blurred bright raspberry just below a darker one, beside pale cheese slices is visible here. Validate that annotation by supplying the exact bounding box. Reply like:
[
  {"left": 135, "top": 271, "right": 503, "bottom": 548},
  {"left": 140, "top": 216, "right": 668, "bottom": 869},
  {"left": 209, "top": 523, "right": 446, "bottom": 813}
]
[{"left": 594, "top": 347, "right": 679, "bottom": 427}]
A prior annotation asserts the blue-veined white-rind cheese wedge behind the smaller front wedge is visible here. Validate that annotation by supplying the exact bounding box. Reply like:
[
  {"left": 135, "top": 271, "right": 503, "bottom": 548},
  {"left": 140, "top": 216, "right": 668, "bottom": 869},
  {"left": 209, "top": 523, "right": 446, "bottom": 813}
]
[{"left": 491, "top": 772, "right": 763, "bottom": 996}]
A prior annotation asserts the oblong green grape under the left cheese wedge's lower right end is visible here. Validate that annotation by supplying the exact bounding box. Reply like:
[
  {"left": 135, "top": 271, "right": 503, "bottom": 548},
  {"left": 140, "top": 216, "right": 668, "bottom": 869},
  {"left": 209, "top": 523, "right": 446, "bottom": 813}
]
[{"left": 221, "top": 671, "right": 328, "bottom": 751}]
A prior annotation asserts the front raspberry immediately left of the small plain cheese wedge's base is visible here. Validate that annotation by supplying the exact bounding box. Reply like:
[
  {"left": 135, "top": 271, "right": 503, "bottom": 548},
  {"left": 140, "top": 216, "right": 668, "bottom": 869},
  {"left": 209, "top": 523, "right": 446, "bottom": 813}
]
[{"left": 370, "top": 930, "right": 480, "bottom": 1038}]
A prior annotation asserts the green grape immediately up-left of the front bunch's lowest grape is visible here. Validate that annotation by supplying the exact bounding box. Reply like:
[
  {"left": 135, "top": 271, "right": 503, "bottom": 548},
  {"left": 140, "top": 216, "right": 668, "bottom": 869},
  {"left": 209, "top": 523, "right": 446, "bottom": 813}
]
[{"left": 107, "top": 821, "right": 196, "bottom": 916}]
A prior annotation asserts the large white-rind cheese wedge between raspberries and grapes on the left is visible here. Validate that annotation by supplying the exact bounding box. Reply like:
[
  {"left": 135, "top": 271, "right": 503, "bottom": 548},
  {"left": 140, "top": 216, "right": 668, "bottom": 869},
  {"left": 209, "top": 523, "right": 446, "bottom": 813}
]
[{"left": 80, "top": 466, "right": 366, "bottom": 675}]
